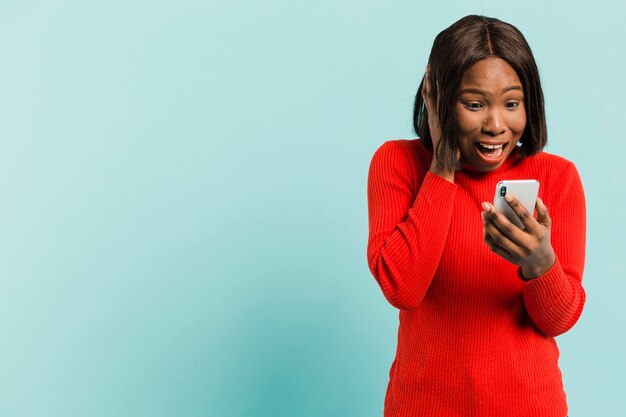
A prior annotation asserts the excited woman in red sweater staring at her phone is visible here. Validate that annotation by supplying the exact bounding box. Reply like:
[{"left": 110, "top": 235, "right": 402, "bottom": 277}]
[{"left": 367, "top": 16, "right": 585, "bottom": 417}]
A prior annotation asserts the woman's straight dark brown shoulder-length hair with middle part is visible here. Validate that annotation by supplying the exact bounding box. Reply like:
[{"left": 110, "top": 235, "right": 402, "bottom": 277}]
[{"left": 413, "top": 15, "right": 547, "bottom": 169}]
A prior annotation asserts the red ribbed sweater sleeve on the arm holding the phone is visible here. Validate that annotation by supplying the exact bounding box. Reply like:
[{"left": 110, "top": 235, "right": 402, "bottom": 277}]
[{"left": 524, "top": 163, "right": 586, "bottom": 337}]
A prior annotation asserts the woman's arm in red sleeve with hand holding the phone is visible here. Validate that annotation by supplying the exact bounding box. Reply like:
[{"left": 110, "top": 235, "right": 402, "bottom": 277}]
[{"left": 483, "top": 163, "right": 586, "bottom": 336}]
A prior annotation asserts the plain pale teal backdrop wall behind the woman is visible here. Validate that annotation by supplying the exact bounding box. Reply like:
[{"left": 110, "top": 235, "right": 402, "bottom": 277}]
[{"left": 0, "top": 0, "right": 626, "bottom": 417}]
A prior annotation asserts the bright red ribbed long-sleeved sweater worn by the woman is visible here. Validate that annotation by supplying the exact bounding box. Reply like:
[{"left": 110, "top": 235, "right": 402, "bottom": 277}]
[{"left": 367, "top": 139, "right": 585, "bottom": 417}]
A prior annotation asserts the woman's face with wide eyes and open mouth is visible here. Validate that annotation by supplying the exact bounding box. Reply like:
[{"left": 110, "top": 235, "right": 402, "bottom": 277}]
[{"left": 455, "top": 58, "right": 526, "bottom": 172}]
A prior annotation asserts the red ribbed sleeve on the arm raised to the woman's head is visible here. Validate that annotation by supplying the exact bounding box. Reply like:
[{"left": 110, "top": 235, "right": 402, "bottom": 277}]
[{"left": 367, "top": 141, "right": 457, "bottom": 310}]
